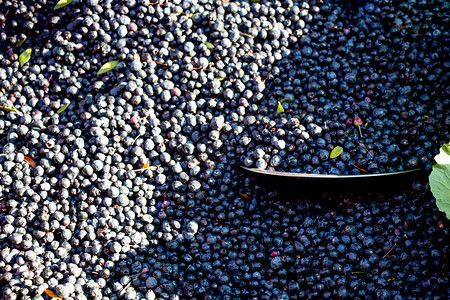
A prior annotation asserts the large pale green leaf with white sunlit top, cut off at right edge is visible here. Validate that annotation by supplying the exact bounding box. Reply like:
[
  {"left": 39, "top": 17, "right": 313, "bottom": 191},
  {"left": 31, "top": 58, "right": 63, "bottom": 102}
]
[{"left": 429, "top": 143, "right": 450, "bottom": 220}]
